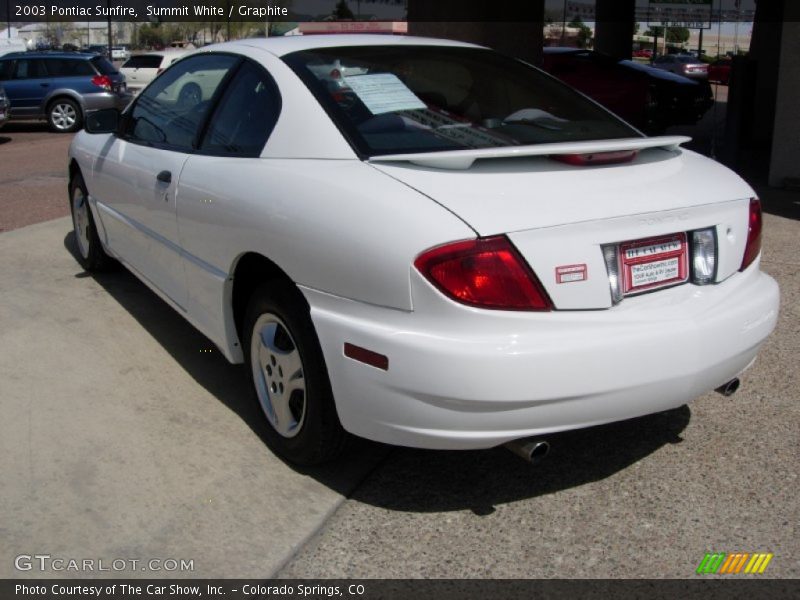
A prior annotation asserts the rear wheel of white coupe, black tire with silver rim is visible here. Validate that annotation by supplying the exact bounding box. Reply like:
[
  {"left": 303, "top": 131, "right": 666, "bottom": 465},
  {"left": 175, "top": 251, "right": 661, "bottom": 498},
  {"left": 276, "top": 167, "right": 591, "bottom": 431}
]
[{"left": 242, "top": 281, "right": 348, "bottom": 465}]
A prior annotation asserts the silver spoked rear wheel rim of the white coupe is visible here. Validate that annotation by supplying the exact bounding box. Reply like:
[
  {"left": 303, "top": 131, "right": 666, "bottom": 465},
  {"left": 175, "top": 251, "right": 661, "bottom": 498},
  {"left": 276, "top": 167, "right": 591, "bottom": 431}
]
[{"left": 250, "top": 313, "right": 306, "bottom": 438}]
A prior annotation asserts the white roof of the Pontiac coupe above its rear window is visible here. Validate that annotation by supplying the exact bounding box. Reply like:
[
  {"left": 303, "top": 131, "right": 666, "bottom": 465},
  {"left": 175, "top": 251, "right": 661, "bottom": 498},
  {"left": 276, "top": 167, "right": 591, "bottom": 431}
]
[{"left": 201, "top": 33, "right": 481, "bottom": 56}]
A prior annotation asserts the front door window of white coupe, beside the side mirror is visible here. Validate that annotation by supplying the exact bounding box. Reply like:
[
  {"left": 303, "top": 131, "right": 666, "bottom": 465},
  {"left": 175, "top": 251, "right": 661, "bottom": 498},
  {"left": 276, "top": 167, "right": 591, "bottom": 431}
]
[{"left": 125, "top": 54, "right": 240, "bottom": 151}]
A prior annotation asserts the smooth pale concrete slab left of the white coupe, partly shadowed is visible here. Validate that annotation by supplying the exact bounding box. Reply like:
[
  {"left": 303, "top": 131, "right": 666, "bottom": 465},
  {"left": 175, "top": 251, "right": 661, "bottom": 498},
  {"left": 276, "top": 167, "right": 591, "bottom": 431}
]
[{"left": 0, "top": 219, "right": 382, "bottom": 578}]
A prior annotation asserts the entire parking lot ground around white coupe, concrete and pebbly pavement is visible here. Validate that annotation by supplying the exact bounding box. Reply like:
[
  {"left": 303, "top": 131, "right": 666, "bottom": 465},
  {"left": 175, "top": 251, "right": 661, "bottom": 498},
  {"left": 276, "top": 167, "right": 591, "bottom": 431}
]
[{"left": 0, "top": 114, "right": 800, "bottom": 578}]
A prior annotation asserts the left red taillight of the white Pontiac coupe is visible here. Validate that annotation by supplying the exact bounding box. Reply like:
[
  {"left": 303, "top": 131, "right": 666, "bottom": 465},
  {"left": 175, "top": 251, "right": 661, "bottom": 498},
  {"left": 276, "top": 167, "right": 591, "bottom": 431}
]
[{"left": 414, "top": 236, "right": 553, "bottom": 311}]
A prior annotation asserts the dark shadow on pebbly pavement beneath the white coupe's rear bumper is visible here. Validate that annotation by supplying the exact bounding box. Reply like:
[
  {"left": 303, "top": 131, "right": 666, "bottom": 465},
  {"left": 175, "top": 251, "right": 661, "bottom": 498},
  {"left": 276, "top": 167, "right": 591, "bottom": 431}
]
[{"left": 352, "top": 406, "right": 691, "bottom": 515}]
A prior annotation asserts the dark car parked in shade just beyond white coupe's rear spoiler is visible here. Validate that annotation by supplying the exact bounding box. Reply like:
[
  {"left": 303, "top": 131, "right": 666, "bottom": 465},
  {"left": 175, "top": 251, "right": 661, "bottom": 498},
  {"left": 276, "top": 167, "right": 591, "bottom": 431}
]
[{"left": 543, "top": 48, "right": 714, "bottom": 133}]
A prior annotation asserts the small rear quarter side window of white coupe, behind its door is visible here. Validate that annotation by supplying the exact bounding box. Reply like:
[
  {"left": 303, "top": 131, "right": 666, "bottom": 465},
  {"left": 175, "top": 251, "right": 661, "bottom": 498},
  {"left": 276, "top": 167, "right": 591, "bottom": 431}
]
[{"left": 200, "top": 62, "right": 280, "bottom": 156}]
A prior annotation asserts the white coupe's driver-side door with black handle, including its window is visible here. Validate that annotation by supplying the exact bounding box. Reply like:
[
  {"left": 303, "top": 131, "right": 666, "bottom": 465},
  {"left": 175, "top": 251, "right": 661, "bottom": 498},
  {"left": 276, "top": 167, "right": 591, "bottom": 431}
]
[{"left": 90, "top": 54, "right": 241, "bottom": 308}]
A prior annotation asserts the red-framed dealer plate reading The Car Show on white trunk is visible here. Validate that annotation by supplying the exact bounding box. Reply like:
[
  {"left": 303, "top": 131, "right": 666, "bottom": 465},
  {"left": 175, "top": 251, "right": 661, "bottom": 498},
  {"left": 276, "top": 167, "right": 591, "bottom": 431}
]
[{"left": 619, "top": 233, "right": 689, "bottom": 294}]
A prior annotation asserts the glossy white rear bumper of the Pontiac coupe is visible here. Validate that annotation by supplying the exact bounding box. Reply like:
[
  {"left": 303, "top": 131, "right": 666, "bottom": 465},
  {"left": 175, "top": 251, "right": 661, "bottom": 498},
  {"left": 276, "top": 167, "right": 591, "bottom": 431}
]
[{"left": 303, "top": 267, "right": 779, "bottom": 449}]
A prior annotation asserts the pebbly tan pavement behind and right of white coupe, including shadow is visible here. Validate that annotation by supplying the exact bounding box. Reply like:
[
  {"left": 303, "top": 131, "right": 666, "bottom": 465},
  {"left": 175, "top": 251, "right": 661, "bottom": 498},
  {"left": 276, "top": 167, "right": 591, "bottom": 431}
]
[{"left": 279, "top": 205, "right": 800, "bottom": 579}]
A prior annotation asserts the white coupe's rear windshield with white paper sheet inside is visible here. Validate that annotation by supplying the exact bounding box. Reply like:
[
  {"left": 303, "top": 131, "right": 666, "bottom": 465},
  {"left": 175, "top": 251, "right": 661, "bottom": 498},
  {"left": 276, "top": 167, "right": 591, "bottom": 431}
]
[{"left": 284, "top": 46, "right": 641, "bottom": 156}]
